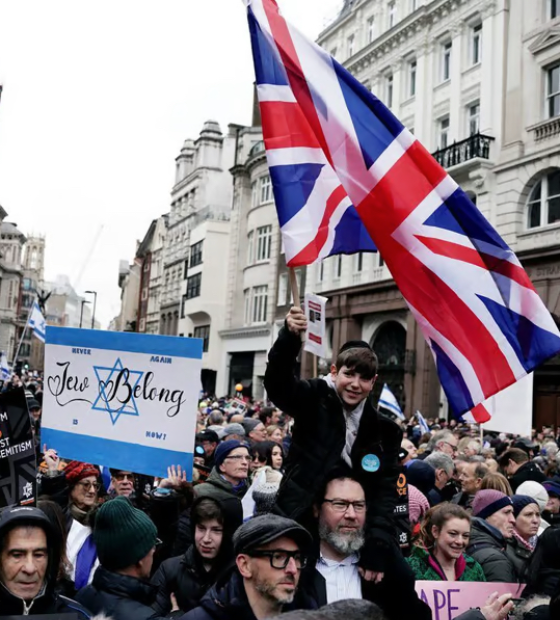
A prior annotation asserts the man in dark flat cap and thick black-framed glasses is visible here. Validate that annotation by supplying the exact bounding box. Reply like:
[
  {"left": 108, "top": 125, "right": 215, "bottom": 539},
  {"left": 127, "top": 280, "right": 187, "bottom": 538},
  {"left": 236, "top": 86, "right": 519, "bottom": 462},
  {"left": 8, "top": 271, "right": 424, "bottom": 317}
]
[{"left": 181, "top": 514, "right": 316, "bottom": 620}]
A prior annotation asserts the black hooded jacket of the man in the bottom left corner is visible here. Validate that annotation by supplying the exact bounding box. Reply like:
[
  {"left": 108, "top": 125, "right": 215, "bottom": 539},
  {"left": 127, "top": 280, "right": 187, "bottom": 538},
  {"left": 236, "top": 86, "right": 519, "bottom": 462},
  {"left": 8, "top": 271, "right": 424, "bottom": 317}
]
[{"left": 0, "top": 507, "right": 91, "bottom": 619}]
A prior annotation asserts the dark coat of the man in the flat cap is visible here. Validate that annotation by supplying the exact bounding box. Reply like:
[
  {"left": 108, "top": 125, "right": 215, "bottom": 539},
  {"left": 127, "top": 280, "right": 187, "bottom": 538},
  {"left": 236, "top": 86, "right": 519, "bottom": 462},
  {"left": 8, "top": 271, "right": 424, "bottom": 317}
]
[{"left": 180, "top": 569, "right": 317, "bottom": 620}]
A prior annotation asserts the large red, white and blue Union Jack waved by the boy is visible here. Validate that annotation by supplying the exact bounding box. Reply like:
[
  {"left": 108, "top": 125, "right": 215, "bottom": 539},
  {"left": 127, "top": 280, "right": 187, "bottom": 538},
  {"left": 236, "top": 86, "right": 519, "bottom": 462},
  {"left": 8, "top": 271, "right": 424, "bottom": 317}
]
[{"left": 245, "top": 0, "right": 560, "bottom": 421}]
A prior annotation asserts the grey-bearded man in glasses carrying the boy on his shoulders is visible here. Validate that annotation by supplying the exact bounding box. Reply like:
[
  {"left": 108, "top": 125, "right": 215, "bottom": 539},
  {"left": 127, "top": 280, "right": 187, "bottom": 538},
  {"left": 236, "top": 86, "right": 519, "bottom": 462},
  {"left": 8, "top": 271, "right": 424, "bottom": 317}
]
[{"left": 301, "top": 471, "right": 431, "bottom": 620}]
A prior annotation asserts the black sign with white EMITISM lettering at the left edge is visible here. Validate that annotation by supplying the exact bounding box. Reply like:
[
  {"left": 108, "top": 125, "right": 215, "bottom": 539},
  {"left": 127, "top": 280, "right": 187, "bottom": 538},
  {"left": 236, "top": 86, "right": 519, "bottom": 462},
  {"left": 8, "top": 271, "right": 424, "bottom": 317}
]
[{"left": 0, "top": 388, "right": 37, "bottom": 510}]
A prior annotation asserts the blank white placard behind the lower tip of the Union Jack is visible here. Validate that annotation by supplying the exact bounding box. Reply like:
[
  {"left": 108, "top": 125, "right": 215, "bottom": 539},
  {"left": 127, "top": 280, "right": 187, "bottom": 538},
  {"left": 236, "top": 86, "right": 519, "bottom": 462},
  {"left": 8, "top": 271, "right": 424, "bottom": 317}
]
[{"left": 482, "top": 373, "right": 533, "bottom": 437}]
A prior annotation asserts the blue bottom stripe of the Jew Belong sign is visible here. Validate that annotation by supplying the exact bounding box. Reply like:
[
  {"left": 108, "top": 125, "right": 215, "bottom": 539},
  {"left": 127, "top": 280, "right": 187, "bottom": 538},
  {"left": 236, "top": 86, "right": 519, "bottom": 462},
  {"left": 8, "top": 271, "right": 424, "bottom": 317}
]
[{"left": 41, "top": 428, "right": 193, "bottom": 480}]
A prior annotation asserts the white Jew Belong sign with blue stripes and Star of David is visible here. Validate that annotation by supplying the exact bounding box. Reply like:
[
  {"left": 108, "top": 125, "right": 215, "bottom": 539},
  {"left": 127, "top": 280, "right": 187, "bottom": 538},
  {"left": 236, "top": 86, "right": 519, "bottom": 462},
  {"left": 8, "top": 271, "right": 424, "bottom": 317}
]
[{"left": 41, "top": 326, "right": 202, "bottom": 477}]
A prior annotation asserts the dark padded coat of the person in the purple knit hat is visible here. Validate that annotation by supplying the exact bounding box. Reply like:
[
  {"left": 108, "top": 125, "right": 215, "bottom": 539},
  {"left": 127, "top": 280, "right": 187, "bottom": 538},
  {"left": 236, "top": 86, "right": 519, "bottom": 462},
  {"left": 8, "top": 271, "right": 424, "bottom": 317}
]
[{"left": 467, "top": 517, "right": 518, "bottom": 583}]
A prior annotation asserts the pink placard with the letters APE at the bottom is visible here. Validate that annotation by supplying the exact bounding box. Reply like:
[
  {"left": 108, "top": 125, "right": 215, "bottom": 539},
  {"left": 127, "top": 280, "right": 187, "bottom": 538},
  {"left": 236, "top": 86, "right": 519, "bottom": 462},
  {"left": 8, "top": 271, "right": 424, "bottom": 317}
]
[{"left": 416, "top": 581, "right": 525, "bottom": 620}]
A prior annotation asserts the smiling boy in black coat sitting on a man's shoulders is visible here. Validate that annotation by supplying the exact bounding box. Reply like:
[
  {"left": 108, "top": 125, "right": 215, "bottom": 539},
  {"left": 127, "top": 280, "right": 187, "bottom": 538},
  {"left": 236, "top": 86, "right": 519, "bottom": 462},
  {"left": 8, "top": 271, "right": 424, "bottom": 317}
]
[{"left": 264, "top": 307, "right": 402, "bottom": 582}]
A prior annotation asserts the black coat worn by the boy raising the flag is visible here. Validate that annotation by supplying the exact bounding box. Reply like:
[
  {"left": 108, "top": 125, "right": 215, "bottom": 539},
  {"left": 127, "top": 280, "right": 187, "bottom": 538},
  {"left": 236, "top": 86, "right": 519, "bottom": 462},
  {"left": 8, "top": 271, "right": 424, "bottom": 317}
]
[{"left": 264, "top": 327, "right": 402, "bottom": 571}]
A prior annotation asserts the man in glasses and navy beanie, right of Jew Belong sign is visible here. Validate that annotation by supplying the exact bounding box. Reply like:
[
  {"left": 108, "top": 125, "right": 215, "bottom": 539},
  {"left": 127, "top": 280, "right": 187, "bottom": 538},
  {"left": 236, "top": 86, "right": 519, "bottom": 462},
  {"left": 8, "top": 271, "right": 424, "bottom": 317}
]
[{"left": 195, "top": 439, "right": 251, "bottom": 501}]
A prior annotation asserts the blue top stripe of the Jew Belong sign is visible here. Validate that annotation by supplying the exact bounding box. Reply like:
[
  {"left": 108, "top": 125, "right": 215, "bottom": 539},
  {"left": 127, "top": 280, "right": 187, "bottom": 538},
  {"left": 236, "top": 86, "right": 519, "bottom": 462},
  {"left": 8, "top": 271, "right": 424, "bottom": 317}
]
[{"left": 46, "top": 325, "right": 203, "bottom": 359}]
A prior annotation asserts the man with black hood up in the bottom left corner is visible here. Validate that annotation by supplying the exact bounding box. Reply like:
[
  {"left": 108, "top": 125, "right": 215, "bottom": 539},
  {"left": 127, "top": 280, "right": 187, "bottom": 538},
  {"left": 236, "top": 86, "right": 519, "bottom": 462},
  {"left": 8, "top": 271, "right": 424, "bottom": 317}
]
[{"left": 0, "top": 506, "right": 90, "bottom": 619}]
